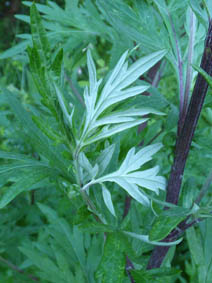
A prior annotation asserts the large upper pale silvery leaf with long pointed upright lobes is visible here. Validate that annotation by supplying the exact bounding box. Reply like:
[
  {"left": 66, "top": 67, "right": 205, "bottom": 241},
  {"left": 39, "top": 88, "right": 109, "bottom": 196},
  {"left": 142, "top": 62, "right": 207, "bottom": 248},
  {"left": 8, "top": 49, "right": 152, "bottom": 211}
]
[{"left": 78, "top": 50, "right": 166, "bottom": 151}]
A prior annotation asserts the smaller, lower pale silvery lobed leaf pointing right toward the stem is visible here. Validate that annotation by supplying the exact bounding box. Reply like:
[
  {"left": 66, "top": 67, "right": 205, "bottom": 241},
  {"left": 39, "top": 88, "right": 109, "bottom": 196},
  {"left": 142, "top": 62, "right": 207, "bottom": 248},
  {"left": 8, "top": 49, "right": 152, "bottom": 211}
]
[{"left": 82, "top": 144, "right": 166, "bottom": 206}]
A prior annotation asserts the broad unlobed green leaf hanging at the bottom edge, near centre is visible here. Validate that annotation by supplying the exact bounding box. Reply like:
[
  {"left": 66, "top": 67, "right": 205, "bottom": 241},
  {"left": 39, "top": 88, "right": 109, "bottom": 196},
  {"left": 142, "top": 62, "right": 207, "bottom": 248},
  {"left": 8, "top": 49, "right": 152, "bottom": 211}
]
[{"left": 96, "top": 233, "right": 125, "bottom": 283}]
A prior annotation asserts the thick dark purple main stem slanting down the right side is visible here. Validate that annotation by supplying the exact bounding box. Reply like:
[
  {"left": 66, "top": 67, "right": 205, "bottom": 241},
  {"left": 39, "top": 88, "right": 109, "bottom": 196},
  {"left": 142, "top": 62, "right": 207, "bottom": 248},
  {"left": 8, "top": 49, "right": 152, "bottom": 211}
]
[{"left": 147, "top": 21, "right": 212, "bottom": 269}]
